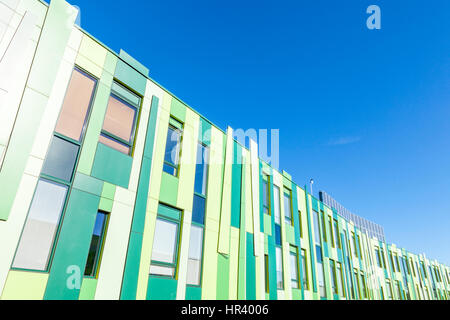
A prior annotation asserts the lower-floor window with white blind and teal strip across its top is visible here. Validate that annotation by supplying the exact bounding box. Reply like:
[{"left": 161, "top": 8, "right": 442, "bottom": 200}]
[{"left": 150, "top": 205, "right": 181, "bottom": 278}]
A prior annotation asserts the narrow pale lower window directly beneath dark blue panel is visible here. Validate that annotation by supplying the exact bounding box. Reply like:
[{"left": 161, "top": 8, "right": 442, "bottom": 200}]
[{"left": 186, "top": 225, "right": 203, "bottom": 286}]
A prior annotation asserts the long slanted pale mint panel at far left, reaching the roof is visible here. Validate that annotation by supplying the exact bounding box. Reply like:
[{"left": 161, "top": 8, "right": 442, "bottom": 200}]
[{"left": 0, "top": 0, "right": 74, "bottom": 220}]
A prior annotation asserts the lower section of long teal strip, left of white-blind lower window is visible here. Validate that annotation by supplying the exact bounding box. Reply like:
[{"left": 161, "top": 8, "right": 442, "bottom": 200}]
[{"left": 120, "top": 232, "right": 143, "bottom": 300}]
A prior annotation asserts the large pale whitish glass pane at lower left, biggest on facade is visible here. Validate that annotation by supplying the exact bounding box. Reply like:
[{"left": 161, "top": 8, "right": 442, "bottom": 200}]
[{"left": 13, "top": 180, "right": 67, "bottom": 271}]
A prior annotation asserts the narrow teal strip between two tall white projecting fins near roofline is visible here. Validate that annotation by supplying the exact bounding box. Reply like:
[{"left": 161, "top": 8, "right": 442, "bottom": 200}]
[{"left": 230, "top": 142, "right": 245, "bottom": 229}]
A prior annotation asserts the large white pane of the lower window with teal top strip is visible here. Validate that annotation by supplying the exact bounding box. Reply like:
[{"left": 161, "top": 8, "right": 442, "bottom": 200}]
[{"left": 152, "top": 218, "right": 178, "bottom": 263}]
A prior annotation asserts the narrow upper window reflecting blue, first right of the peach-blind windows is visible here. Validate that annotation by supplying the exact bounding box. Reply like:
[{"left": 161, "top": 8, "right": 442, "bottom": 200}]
[{"left": 163, "top": 118, "right": 183, "bottom": 176}]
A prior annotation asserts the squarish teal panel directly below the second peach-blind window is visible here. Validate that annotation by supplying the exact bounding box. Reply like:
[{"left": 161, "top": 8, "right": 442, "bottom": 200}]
[{"left": 92, "top": 143, "right": 133, "bottom": 189}]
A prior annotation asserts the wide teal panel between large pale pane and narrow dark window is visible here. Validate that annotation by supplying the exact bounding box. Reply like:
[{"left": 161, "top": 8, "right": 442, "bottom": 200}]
[{"left": 44, "top": 189, "right": 100, "bottom": 300}]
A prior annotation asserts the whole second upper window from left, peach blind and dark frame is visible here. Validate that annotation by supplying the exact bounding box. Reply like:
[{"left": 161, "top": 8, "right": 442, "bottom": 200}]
[{"left": 99, "top": 82, "right": 141, "bottom": 155}]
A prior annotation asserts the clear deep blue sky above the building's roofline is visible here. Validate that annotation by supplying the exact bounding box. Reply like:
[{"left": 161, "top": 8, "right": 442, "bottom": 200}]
[{"left": 69, "top": 0, "right": 450, "bottom": 265}]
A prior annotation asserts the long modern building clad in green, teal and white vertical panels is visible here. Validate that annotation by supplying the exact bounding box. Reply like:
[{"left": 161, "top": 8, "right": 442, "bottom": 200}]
[{"left": 0, "top": 0, "right": 450, "bottom": 300}]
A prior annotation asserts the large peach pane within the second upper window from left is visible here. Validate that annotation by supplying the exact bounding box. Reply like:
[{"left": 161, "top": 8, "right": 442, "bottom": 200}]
[{"left": 103, "top": 96, "right": 136, "bottom": 142}]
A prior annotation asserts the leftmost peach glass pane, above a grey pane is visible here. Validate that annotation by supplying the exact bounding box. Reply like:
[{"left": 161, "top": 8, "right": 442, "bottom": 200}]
[{"left": 55, "top": 69, "right": 96, "bottom": 141}]
